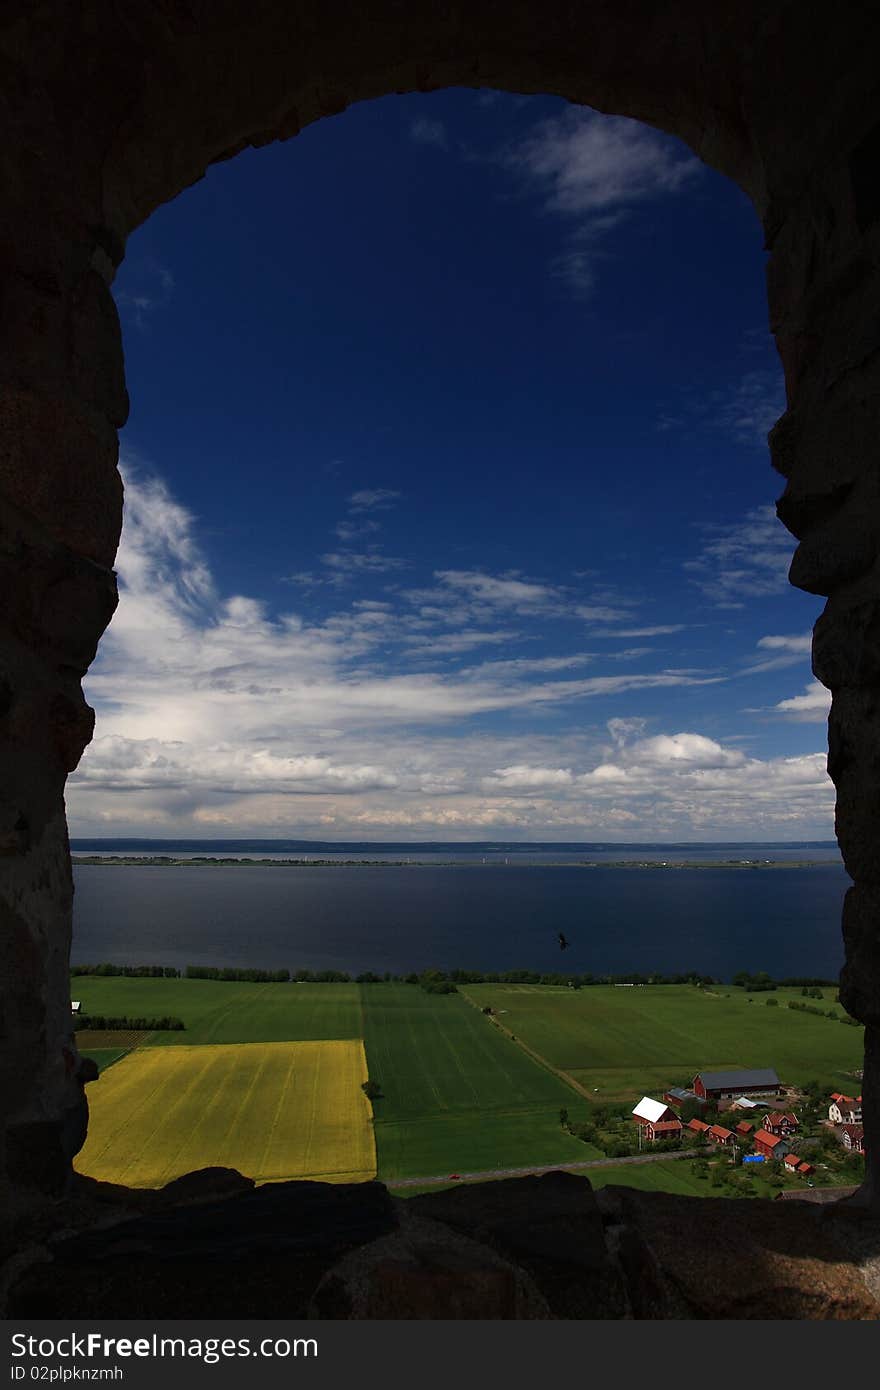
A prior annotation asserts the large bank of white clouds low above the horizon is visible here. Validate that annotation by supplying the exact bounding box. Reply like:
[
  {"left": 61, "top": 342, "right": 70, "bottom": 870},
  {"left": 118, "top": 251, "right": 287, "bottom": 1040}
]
[{"left": 68, "top": 468, "right": 827, "bottom": 838}]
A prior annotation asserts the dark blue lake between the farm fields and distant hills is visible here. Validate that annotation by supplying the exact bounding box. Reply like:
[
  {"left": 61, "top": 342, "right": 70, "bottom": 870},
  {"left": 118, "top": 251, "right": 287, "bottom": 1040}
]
[{"left": 72, "top": 841, "right": 851, "bottom": 980}]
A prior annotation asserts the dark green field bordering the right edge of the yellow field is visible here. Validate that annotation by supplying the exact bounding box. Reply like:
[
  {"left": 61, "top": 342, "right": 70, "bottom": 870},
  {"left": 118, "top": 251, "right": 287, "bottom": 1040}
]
[{"left": 361, "top": 984, "right": 598, "bottom": 1179}]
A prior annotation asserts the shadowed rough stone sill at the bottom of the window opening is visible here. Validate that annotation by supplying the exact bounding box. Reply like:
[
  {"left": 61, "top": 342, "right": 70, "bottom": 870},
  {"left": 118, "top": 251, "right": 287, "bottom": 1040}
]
[{"left": 4, "top": 1169, "right": 880, "bottom": 1321}]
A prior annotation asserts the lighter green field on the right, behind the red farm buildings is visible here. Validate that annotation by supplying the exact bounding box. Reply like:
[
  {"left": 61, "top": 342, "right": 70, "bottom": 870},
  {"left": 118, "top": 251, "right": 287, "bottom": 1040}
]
[{"left": 466, "top": 984, "right": 863, "bottom": 1099}]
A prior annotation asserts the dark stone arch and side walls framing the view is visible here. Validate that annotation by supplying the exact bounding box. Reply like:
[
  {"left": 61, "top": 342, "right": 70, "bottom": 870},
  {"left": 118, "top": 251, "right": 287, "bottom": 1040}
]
[{"left": 0, "top": 0, "right": 880, "bottom": 1245}]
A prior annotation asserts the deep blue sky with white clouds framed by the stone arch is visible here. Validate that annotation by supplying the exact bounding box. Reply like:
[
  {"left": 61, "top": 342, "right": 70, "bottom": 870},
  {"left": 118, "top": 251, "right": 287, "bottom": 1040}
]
[{"left": 68, "top": 90, "right": 833, "bottom": 841}]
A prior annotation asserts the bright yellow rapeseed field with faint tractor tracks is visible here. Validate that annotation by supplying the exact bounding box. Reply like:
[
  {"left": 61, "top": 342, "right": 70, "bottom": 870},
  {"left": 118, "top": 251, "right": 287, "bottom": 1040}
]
[{"left": 75, "top": 1040, "right": 375, "bottom": 1187}]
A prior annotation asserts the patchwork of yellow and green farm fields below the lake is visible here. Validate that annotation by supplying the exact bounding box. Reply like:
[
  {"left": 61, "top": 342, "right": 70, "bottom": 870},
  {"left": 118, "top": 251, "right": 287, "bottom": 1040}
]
[{"left": 70, "top": 977, "right": 862, "bottom": 1193}]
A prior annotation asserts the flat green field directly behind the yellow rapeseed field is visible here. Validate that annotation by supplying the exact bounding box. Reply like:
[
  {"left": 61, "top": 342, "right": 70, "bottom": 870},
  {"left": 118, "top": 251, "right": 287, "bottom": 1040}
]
[{"left": 72, "top": 976, "right": 363, "bottom": 1047}]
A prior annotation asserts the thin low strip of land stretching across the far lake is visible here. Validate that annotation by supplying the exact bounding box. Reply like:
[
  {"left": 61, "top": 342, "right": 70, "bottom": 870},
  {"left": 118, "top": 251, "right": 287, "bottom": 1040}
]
[{"left": 71, "top": 855, "right": 842, "bottom": 869}]
